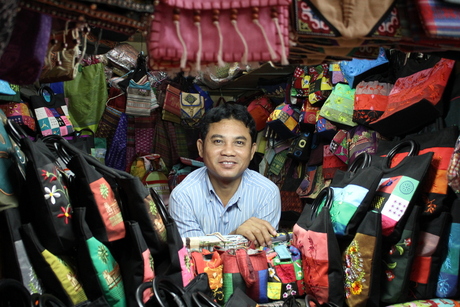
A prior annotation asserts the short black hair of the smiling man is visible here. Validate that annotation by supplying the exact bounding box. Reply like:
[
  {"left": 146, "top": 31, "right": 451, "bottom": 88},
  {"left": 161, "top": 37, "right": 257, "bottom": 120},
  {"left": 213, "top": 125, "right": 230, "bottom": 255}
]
[{"left": 200, "top": 102, "right": 257, "bottom": 143}]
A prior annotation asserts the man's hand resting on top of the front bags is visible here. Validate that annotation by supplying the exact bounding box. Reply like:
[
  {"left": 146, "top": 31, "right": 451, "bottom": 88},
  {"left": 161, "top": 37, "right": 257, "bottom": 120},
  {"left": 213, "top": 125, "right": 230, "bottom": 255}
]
[{"left": 234, "top": 217, "right": 276, "bottom": 246}]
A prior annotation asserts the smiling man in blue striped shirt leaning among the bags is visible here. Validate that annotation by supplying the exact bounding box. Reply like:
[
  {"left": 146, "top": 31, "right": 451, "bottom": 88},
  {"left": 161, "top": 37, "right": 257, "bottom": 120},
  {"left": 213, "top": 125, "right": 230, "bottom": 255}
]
[{"left": 169, "top": 103, "right": 281, "bottom": 246}]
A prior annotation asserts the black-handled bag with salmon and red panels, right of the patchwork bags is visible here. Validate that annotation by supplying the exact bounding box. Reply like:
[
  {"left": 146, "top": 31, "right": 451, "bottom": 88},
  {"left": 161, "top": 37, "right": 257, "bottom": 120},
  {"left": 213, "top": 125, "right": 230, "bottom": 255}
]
[{"left": 292, "top": 187, "right": 345, "bottom": 306}]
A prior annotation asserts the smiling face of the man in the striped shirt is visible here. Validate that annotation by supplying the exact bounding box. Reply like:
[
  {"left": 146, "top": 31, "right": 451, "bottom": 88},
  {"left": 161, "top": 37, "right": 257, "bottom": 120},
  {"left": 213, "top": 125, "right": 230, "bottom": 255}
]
[{"left": 197, "top": 119, "right": 256, "bottom": 184}]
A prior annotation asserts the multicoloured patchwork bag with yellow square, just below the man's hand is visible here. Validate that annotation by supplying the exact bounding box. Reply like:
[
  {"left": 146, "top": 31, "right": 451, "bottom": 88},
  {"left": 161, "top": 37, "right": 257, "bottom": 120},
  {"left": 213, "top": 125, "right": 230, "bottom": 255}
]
[{"left": 264, "top": 242, "right": 305, "bottom": 301}]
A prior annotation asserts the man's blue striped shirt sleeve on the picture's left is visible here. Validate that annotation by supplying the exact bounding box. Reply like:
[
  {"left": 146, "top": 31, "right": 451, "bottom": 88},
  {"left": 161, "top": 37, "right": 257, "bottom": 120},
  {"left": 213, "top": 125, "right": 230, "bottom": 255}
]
[{"left": 169, "top": 190, "right": 205, "bottom": 238}]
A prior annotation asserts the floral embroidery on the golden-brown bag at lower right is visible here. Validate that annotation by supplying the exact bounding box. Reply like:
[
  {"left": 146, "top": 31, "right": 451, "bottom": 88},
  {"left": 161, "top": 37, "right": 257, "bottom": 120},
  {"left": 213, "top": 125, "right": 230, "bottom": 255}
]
[{"left": 344, "top": 240, "right": 366, "bottom": 298}]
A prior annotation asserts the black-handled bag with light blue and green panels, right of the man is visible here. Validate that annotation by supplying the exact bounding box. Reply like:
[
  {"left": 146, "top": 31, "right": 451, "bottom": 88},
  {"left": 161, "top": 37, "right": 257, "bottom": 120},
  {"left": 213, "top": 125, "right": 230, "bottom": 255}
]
[{"left": 330, "top": 153, "right": 383, "bottom": 237}]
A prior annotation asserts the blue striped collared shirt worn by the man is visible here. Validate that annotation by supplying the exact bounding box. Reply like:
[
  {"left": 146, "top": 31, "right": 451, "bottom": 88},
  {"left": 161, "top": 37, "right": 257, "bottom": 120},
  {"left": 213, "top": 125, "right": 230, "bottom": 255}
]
[{"left": 169, "top": 166, "right": 281, "bottom": 238}]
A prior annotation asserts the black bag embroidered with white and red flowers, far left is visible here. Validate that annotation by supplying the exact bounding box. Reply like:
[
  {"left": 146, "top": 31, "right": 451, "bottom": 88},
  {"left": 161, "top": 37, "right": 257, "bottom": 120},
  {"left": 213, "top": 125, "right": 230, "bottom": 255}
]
[{"left": 15, "top": 127, "right": 76, "bottom": 255}]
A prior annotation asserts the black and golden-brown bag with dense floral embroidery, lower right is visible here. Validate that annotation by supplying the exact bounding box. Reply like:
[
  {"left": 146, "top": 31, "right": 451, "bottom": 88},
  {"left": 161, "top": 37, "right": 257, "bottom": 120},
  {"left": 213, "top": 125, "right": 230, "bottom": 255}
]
[{"left": 343, "top": 210, "right": 382, "bottom": 306}]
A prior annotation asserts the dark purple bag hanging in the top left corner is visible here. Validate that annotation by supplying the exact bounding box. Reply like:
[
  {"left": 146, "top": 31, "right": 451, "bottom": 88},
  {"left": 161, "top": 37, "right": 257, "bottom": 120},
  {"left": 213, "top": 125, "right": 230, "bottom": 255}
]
[{"left": 0, "top": 9, "right": 52, "bottom": 85}]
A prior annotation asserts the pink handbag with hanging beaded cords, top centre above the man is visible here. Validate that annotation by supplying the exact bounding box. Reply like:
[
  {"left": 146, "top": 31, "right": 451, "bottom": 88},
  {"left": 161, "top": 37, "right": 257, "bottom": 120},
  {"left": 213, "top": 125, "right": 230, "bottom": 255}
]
[{"left": 148, "top": 0, "right": 291, "bottom": 71}]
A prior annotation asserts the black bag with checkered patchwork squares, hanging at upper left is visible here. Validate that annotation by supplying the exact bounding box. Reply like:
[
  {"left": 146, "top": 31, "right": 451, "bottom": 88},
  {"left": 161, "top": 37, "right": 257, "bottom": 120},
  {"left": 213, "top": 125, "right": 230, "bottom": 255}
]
[{"left": 30, "top": 85, "right": 74, "bottom": 136}]
